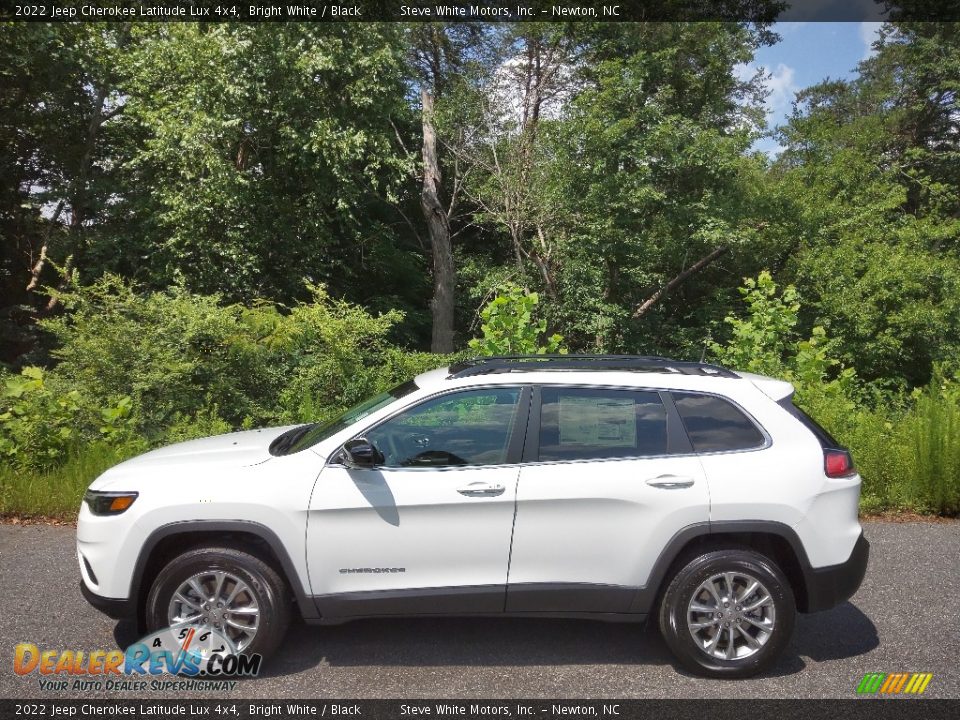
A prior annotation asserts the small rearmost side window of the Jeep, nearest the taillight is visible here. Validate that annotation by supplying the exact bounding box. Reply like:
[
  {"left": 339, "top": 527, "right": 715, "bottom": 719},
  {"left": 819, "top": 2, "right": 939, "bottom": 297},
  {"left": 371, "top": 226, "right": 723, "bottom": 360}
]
[{"left": 673, "top": 393, "right": 764, "bottom": 452}]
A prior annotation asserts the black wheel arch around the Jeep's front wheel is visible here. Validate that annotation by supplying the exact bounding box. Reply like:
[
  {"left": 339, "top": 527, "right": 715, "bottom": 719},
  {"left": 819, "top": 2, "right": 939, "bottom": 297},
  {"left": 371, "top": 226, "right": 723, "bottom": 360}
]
[{"left": 130, "top": 520, "right": 318, "bottom": 627}]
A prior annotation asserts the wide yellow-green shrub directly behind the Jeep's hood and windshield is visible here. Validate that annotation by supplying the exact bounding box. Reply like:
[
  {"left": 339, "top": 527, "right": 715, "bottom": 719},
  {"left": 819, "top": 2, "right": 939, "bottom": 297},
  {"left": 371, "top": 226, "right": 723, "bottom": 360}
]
[{"left": 43, "top": 276, "right": 443, "bottom": 443}]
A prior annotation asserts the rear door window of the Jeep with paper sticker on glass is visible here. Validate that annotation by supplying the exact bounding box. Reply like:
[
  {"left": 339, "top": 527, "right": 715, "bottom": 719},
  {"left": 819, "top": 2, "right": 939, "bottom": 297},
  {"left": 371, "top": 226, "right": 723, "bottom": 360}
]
[{"left": 540, "top": 387, "right": 667, "bottom": 462}]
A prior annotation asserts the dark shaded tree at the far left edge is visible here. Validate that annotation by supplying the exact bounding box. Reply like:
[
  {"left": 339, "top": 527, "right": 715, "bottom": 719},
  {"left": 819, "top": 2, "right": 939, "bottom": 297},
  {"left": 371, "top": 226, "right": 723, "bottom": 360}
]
[{"left": 0, "top": 23, "right": 128, "bottom": 354}]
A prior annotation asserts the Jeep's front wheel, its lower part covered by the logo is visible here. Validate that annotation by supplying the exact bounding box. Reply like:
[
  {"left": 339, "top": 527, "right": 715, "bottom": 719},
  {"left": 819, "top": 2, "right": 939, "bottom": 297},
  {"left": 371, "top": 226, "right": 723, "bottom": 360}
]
[{"left": 146, "top": 548, "right": 290, "bottom": 656}]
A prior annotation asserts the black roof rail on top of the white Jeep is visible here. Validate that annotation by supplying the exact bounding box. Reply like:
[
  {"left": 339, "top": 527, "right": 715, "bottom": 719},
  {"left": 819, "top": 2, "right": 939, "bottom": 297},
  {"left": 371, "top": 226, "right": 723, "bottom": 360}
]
[{"left": 447, "top": 355, "right": 739, "bottom": 379}]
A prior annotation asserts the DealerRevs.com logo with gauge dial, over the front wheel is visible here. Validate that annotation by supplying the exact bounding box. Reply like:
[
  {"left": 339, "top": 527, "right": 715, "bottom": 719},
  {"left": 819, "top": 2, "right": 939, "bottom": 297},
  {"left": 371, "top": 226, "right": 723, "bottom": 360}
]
[{"left": 13, "top": 627, "right": 263, "bottom": 692}]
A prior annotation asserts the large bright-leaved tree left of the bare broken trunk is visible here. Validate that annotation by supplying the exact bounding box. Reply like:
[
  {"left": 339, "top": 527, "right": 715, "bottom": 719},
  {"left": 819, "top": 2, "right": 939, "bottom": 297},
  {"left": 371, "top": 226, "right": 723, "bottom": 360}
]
[{"left": 106, "top": 23, "right": 423, "bottom": 307}]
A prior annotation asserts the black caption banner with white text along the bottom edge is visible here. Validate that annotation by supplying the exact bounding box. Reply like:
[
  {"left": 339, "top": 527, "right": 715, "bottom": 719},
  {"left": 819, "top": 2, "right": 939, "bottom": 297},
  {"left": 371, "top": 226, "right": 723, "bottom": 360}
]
[{"left": 0, "top": 700, "right": 960, "bottom": 720}]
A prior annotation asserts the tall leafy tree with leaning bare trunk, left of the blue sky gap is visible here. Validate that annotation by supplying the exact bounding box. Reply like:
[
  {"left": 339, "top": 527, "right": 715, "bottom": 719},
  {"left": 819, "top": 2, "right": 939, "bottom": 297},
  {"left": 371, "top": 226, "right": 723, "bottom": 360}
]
[{"left": 538, "top": 23, "right": 771, "bottom": 355}]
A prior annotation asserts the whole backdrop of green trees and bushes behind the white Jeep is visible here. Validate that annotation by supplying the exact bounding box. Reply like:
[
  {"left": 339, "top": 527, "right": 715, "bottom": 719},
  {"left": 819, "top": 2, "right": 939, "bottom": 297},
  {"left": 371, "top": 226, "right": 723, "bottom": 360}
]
[{"left": 0, "top": 22, "right": 960, "bottom": 512}]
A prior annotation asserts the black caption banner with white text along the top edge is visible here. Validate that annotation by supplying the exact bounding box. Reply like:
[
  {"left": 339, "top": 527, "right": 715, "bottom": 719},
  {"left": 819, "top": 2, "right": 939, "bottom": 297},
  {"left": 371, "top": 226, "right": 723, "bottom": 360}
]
[{"left": 0, "top": 0, "right": 960, "bottom": 22}]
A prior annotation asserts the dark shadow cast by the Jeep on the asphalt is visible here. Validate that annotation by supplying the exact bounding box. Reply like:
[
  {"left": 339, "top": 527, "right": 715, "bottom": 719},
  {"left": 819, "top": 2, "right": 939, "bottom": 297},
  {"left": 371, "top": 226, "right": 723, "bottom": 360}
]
[{"left": 253, "top": 603, "right": 879, "bottom": 677}]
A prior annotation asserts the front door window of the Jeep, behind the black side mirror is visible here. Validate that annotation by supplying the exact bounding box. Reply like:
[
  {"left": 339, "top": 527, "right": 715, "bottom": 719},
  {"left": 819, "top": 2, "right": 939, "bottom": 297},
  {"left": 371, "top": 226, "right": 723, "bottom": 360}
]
[{"left": 366, "top": 388, "right": 520, "bottom": 467}]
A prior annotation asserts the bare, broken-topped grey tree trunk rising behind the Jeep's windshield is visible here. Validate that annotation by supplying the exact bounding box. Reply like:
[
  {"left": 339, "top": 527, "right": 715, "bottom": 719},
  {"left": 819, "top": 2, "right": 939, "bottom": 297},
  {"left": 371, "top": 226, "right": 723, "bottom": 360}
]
[{"left": 420, "top": 88, "right": 456, "bottom": 353}]
